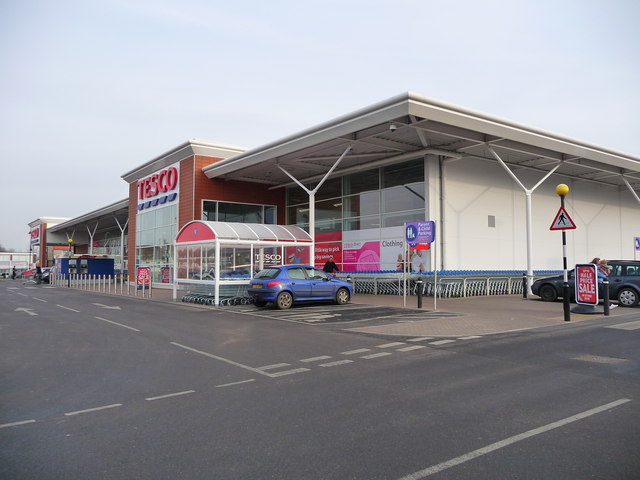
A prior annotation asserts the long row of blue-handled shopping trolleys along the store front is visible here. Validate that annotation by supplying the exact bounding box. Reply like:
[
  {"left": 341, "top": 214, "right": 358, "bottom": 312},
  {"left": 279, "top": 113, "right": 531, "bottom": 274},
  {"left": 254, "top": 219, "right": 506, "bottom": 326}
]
[{"left": 339, "top": 271, "right": 558, "bottom": 298}]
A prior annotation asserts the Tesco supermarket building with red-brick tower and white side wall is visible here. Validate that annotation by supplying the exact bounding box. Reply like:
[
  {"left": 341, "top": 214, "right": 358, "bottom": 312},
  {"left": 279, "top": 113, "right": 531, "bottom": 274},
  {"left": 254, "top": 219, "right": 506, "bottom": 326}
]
[{"left": 29, "top": 93, "right": 640, "bottom": 285}]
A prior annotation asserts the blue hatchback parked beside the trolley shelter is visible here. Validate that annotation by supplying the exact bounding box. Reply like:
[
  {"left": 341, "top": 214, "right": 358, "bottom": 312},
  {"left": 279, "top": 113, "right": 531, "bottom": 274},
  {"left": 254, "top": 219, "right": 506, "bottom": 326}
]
[{"left": 249, "top": 265, "right": 353, "bottom": 310}]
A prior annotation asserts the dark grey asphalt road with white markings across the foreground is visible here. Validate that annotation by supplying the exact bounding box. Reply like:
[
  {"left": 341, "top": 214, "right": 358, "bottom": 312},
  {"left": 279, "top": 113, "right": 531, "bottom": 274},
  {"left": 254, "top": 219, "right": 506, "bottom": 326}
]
[{"left": 0, "top": 280, "right": 640, "bottom": 480}]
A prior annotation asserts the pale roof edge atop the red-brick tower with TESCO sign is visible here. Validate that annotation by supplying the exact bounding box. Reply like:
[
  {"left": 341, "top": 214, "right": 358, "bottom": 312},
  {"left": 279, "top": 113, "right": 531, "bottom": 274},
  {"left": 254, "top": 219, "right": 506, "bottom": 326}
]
[{"left": 120, "top": 138, "right": 246, "bottom": 183}]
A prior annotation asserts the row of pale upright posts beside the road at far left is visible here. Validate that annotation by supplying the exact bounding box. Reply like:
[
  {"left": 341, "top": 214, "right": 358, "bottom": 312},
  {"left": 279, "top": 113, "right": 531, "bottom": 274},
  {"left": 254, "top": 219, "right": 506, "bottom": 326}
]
[{"left": 49, "top": 273, "right": 153, "bottom": 298}]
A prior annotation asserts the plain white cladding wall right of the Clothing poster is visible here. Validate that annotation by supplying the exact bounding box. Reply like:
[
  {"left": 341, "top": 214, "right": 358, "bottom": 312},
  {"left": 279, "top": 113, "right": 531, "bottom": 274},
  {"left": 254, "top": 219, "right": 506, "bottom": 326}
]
[{"left": 442, "top": 159, "right": 640, "bottom": 271}]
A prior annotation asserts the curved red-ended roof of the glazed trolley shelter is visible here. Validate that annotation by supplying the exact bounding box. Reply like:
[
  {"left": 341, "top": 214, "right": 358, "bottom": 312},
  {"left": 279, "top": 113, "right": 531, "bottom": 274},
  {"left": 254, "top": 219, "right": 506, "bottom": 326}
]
[{"left": 176, "top": 220, "right": 312, "bottom": 243}]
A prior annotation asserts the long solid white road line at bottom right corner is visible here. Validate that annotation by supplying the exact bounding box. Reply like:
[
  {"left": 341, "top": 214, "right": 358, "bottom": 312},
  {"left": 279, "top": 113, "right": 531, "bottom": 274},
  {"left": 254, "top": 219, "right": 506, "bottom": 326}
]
[{"left": 399, "top": 398, "right": 631, "bottom": 480}]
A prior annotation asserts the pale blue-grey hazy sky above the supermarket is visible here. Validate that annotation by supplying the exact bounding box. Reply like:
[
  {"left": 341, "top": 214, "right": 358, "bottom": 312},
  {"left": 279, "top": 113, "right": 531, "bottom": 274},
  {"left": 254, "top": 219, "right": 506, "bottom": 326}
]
[{"left": 0, "top": 0, "right": 640, "bottom": 251}]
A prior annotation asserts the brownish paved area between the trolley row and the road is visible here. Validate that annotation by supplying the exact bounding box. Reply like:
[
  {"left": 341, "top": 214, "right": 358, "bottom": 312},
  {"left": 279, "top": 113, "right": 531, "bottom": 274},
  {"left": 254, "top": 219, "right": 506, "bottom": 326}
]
[{"left": 129, "top": 288, "right": 640, "bottom": 337}]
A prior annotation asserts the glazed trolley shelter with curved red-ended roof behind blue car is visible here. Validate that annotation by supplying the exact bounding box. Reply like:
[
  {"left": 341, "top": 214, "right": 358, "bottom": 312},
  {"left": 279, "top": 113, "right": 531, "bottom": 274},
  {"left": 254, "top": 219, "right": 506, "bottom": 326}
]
[{"left": 173, "top": 220, "right": 313, "bottom": 305}]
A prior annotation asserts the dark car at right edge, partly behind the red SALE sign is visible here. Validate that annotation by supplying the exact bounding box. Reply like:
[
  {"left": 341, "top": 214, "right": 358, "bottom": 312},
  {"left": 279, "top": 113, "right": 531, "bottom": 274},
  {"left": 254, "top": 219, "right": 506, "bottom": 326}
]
[{"left": 531, "top": 260, "right": 640, "bottom": 307}]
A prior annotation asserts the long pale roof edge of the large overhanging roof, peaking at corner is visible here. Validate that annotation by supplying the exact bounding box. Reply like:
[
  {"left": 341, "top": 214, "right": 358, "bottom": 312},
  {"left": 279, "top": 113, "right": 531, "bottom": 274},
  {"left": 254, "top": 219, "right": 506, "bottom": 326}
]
[{"left": 202, "top": 92, "right": 640, "bottom": 178}]
